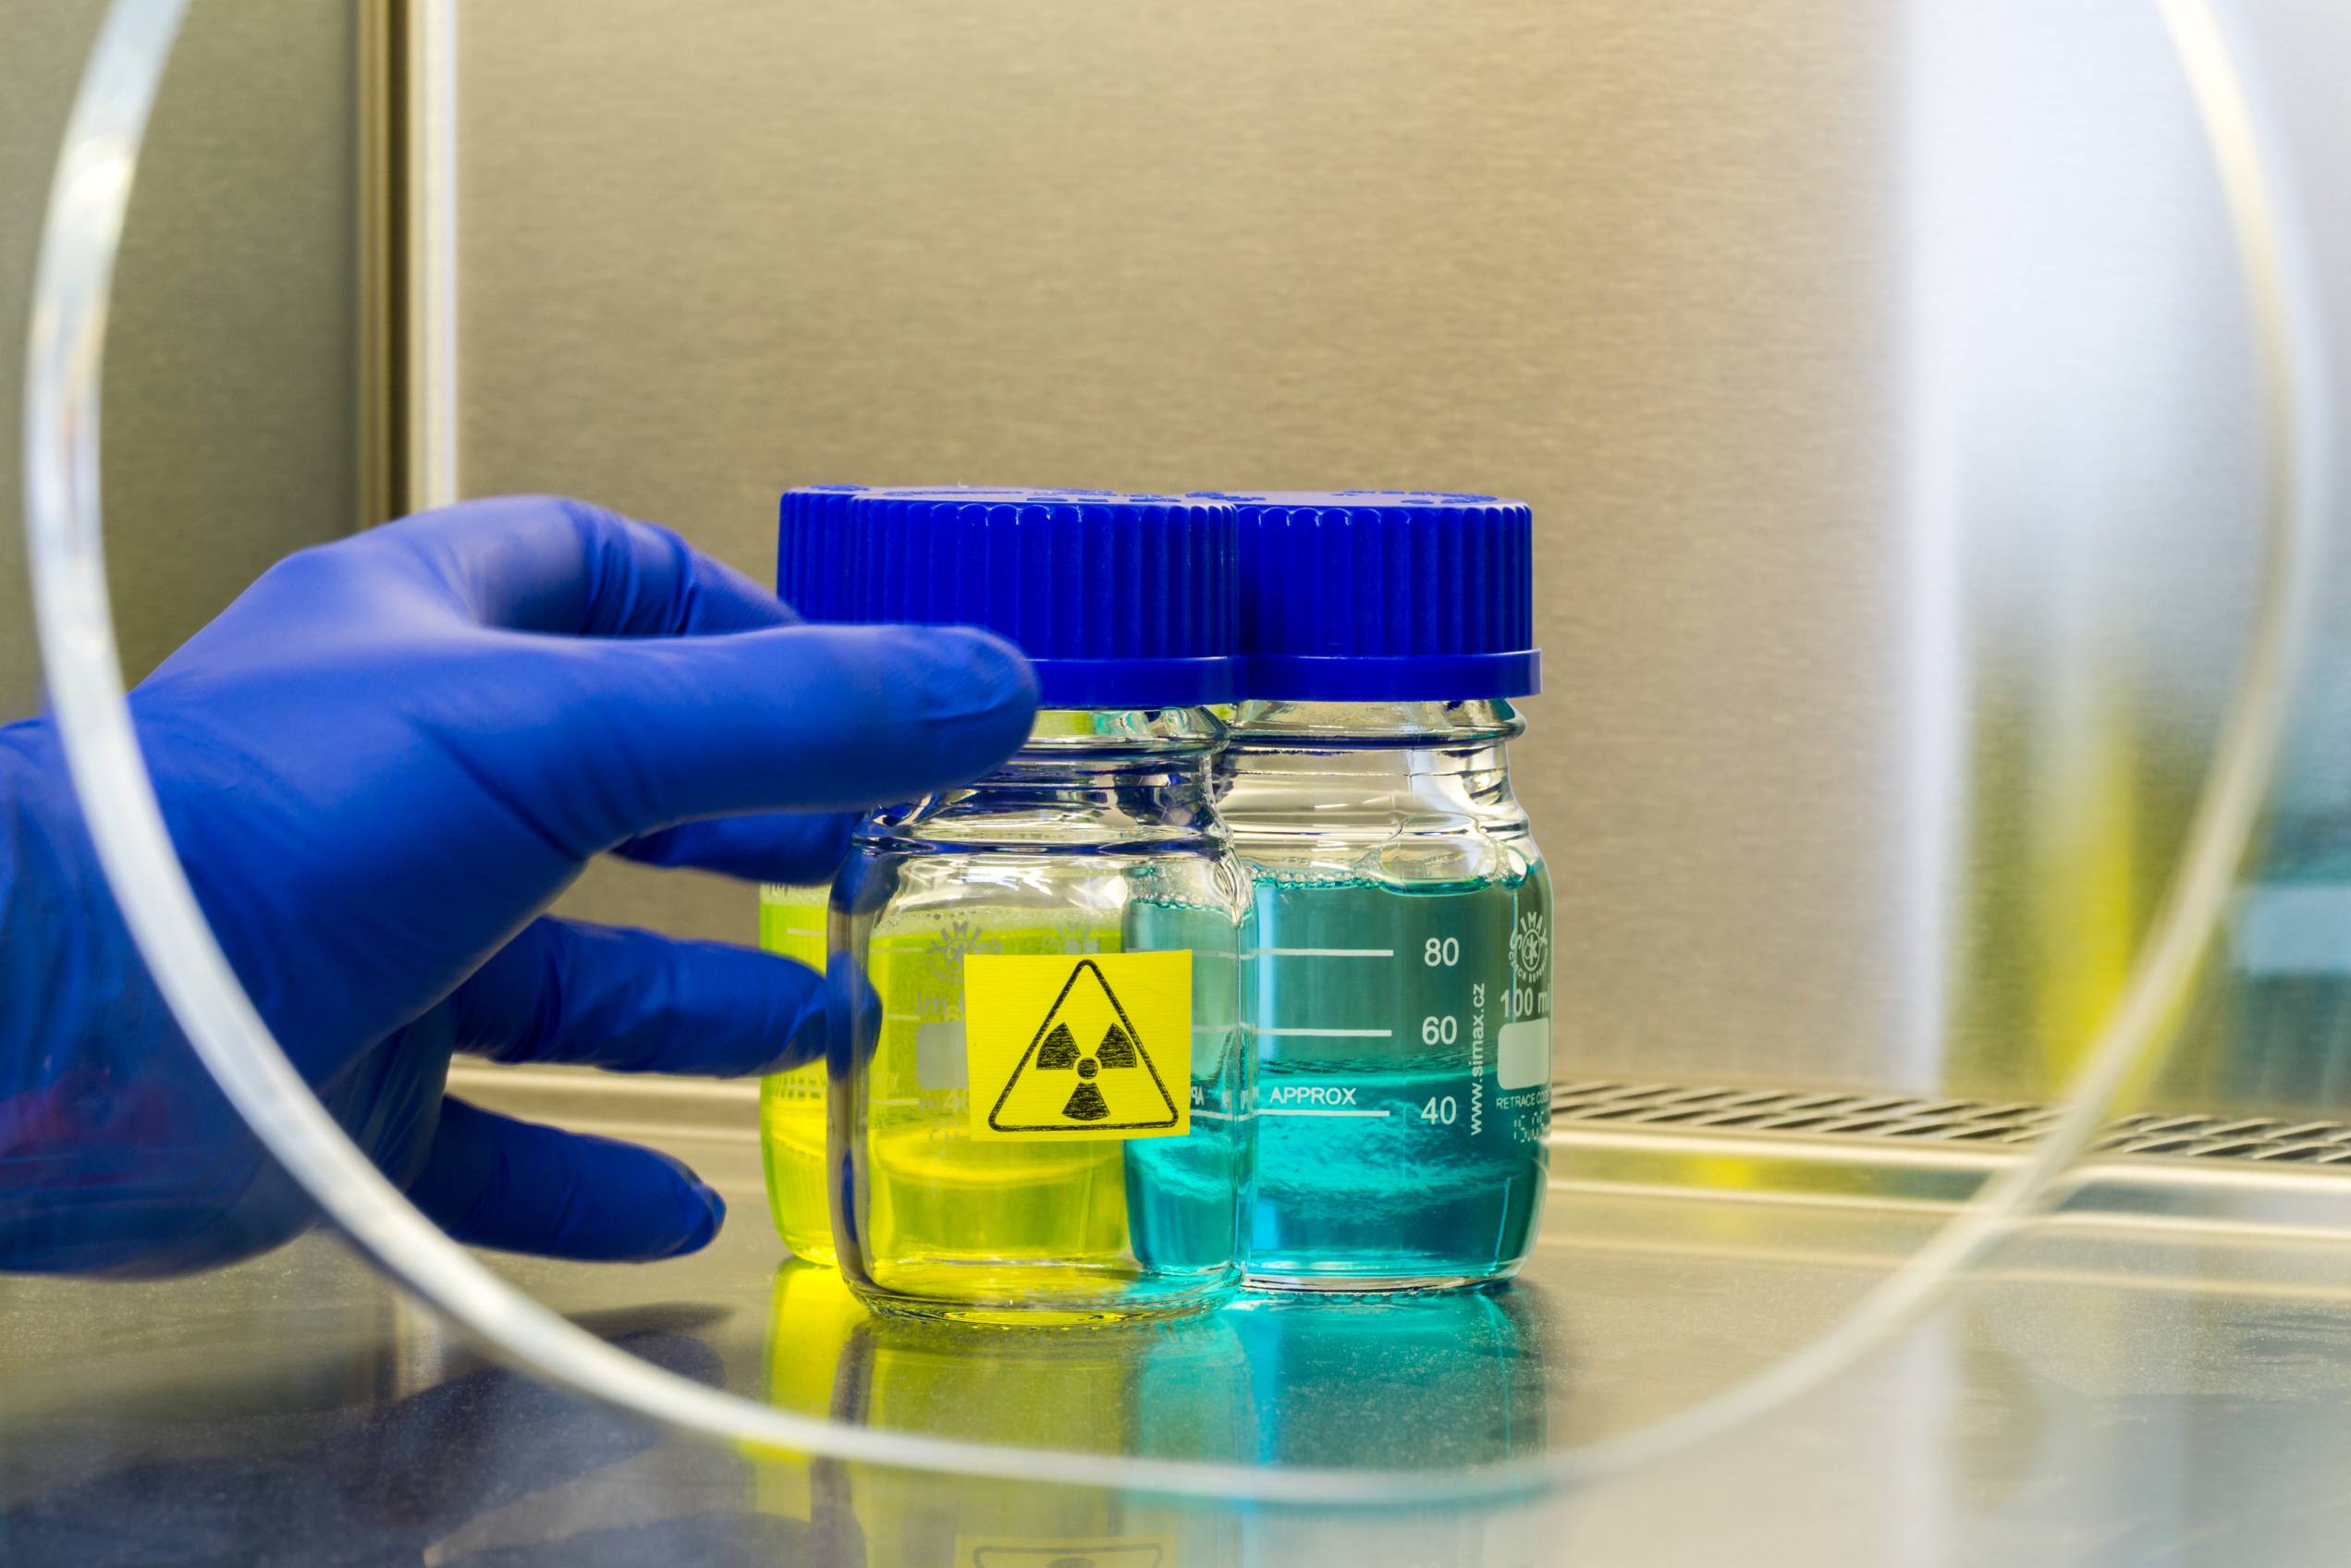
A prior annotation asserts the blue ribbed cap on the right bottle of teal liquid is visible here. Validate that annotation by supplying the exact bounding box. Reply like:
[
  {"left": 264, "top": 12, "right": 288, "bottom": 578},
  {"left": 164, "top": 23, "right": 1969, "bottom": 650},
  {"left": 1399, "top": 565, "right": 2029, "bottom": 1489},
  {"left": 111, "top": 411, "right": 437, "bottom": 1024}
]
[{"left": 1206, "top": 489, "right": 1542, "bottom": 703}]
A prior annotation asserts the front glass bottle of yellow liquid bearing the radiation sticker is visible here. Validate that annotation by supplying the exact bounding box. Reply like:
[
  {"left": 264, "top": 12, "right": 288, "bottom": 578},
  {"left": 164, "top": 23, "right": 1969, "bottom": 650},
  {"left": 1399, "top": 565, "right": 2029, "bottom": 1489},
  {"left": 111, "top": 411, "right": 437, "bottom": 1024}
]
[{"left": 813, "top": 491, "right": 1253, "bottom": 1324}]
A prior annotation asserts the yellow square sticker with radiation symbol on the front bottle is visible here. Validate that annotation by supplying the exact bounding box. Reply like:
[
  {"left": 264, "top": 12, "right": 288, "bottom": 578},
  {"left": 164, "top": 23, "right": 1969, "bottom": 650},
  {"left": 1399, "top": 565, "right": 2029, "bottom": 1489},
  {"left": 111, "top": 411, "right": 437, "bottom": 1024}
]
[{"left": 964, "top": 952, "right": 1192, "bottom": 1140}]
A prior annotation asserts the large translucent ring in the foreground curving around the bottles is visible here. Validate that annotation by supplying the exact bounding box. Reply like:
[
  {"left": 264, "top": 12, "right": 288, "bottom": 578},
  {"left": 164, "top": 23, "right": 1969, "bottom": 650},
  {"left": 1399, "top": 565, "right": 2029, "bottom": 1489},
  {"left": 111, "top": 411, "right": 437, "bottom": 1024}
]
[{"left": 23, "top": 0, "right": 2330, "bottom": 1509}]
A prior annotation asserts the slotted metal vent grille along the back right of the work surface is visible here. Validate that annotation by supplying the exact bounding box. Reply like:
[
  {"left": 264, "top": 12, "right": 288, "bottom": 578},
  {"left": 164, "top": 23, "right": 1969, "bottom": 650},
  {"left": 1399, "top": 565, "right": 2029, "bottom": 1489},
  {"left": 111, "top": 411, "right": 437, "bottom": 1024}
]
[{"left": 1551, "top": 1082, "right": 2351, "bottom": 1166}]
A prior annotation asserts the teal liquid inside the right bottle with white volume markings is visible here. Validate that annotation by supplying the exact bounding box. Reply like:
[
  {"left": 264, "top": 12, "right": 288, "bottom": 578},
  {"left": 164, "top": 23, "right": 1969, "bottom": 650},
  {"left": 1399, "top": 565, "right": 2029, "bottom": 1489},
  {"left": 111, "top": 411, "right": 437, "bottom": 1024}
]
[{"left": 1129, "top": 867, "right": 1551, "bottom": 1291}]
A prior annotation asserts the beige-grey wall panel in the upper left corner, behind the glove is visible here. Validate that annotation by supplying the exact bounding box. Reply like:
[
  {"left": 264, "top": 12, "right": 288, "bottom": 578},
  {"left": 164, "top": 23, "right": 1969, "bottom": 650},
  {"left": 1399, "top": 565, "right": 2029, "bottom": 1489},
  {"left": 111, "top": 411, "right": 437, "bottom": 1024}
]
[{"left": 0, "top": 0, "right": 360, "bottom": 719}]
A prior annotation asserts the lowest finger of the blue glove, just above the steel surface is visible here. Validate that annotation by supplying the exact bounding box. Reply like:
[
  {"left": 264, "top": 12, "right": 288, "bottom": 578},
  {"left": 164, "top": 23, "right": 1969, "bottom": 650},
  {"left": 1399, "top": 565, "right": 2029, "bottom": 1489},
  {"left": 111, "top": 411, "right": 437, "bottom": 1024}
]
[{"left": 409, "top": 1100, "right": 727, "bottom": 1262}]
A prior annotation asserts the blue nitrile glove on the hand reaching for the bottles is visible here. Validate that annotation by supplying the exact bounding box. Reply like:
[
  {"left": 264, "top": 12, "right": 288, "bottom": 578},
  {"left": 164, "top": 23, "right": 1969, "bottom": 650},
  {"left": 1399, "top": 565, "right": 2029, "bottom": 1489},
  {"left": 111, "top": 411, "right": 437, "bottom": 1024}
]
[{"left": 0, "top": 498, "right": 1036, "bottom": 1274}]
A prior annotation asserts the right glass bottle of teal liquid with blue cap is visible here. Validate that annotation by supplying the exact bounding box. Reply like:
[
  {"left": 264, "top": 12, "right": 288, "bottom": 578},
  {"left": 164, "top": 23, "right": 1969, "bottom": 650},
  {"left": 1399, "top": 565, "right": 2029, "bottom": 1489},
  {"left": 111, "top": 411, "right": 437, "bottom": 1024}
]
[{"left": 1218, "top": 491, "right": 1551, "bottom": 1293}]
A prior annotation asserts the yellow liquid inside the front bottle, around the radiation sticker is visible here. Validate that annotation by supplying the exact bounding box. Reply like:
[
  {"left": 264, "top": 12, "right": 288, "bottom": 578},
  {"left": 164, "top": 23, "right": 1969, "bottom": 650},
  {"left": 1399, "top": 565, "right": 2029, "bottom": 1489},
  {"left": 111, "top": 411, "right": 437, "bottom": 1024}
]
[{"left": 865, "top": 910, "right": 1133, "bottom": 1321}]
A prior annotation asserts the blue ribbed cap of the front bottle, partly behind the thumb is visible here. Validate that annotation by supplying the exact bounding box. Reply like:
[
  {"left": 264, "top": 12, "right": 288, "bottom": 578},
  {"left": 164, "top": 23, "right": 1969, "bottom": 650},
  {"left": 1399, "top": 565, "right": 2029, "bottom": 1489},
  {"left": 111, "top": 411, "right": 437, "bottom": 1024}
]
[{"left": 776, "top": 489, "right": 1239, "bottom": 707}]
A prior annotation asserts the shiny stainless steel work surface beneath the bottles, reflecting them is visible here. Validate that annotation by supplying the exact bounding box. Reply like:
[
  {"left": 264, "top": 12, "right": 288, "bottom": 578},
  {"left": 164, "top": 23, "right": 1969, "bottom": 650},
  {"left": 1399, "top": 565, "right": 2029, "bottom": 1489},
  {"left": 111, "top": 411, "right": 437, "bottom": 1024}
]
[{"left": 0, "top": 1074, "right": 2351, "bottom": 1568}]
